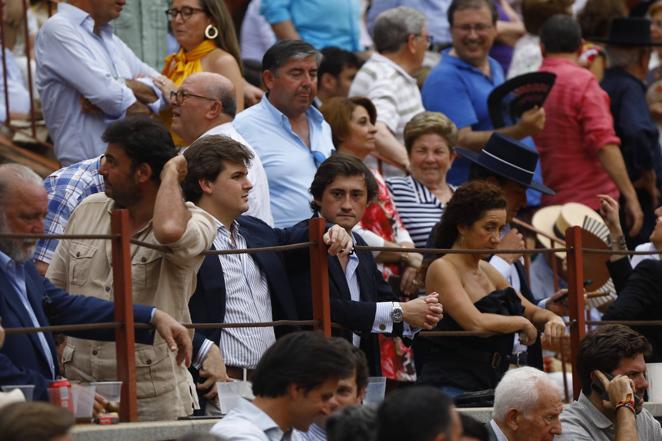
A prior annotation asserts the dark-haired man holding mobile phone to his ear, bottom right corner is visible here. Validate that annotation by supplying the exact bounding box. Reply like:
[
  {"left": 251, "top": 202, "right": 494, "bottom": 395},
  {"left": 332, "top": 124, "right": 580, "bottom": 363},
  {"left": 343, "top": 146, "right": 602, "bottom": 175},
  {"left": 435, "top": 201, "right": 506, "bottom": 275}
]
[{"left": 556, "top": 325, "right": 662, "bottom": 441}]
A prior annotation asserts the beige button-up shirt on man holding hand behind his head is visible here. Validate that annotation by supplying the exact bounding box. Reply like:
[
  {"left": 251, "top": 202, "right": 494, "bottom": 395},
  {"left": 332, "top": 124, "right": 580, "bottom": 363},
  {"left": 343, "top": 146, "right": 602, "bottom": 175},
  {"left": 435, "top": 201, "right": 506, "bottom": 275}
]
[{"left": 46, "top": 193, "right": 216, "bottom": 420}]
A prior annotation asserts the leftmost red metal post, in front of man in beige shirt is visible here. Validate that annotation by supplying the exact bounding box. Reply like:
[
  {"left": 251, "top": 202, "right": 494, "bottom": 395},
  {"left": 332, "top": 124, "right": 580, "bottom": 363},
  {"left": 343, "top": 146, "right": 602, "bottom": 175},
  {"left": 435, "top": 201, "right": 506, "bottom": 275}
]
[{"left": 111, "top": 210, "right": 138, "bottom": 422}]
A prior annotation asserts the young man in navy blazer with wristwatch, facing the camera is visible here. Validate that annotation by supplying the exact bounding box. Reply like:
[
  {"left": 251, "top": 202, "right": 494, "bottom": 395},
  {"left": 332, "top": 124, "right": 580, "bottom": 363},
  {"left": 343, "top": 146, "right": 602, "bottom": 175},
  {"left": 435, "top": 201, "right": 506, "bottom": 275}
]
[{"left": 287, "top": 154, "right": 442, "bottom": 375}]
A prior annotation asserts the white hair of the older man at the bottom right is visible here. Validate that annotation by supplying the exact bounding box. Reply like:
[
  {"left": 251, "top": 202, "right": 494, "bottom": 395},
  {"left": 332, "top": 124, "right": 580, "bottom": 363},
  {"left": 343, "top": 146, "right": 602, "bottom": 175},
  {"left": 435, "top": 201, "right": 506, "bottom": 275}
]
[{"left": 492, "top": 366, "right": 556, "bottom": 422}]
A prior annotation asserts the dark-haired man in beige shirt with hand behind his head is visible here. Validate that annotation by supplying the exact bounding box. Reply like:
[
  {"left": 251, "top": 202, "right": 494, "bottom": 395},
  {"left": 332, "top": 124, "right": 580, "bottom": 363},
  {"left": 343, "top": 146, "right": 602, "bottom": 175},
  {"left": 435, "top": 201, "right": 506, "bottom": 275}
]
[{"left": 47, "top": 116, "right": 215, "bottom": 420}]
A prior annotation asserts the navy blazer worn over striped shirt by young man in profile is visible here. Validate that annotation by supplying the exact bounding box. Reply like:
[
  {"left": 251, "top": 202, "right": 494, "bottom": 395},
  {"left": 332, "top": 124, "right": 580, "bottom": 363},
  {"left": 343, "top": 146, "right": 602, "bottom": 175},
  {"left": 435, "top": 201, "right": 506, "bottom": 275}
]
[{"left": 189, "top": 216, "right": 308, "bottom": 405}]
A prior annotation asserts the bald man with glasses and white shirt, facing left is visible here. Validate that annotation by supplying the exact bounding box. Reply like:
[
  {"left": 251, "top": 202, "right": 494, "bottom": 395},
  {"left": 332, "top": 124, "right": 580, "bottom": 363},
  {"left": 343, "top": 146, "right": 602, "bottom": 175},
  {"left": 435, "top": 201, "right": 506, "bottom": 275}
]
[{"left": 170, "top": 72, "right": 274, "bottom": 226}]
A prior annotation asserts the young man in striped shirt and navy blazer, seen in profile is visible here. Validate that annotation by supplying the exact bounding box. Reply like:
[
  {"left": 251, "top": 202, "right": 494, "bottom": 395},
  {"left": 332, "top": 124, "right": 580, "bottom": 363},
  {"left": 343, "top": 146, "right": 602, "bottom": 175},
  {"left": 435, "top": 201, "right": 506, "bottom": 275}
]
[{"left": 182, "top": 135, "right": 352, "bottom": 414}]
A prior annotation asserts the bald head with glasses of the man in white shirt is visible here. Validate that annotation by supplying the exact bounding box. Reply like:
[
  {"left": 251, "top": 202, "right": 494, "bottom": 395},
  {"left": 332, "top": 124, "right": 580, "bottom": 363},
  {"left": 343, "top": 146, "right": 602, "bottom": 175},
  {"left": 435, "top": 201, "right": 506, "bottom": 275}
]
[{"left": 170, "top": 72, "right": 237, "bottom": 144}]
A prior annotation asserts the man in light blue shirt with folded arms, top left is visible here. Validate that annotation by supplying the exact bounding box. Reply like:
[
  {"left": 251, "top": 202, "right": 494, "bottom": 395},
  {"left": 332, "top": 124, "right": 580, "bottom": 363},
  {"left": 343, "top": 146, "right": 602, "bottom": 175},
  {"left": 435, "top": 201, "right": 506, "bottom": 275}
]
[{"left": 36, "top": 0, "right": 170, "bottom": 165}]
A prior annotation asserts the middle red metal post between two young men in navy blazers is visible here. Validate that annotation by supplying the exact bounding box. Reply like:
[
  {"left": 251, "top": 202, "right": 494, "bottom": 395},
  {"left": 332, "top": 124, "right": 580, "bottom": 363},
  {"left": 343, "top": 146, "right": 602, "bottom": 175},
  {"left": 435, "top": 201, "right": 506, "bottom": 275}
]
[{"left": 308, "top": 217, "right": 331, "bottom": 337}]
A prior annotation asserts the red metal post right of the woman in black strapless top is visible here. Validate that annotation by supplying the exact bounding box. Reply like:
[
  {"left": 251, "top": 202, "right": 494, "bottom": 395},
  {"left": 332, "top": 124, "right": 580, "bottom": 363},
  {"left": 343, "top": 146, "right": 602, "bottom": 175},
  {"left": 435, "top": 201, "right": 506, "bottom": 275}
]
[{"left": 565, "top": 227, "right": 586, "bottom": 399}]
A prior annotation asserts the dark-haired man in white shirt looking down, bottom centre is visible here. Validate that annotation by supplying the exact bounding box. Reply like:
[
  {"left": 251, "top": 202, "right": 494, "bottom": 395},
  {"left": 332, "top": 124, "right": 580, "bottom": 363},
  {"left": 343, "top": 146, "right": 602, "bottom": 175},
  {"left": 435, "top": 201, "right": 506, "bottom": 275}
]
[{"left": 211, "top": 331, "right": 354, "bottom": 441}]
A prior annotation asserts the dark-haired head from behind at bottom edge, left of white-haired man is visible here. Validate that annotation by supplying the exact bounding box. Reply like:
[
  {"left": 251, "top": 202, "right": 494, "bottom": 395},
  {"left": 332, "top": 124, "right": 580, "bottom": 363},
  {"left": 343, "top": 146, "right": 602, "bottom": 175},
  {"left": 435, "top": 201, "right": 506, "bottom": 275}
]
[{"left": 376, "top": 386, "right": 462, "bottom": 441}]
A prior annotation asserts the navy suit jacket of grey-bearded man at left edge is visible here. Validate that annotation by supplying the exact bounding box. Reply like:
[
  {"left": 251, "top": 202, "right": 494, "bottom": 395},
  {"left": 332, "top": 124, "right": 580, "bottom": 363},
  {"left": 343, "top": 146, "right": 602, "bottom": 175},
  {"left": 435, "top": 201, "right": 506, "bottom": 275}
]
[{"left": 0, "top": 262, "right": 154, "bottom": 400}]
